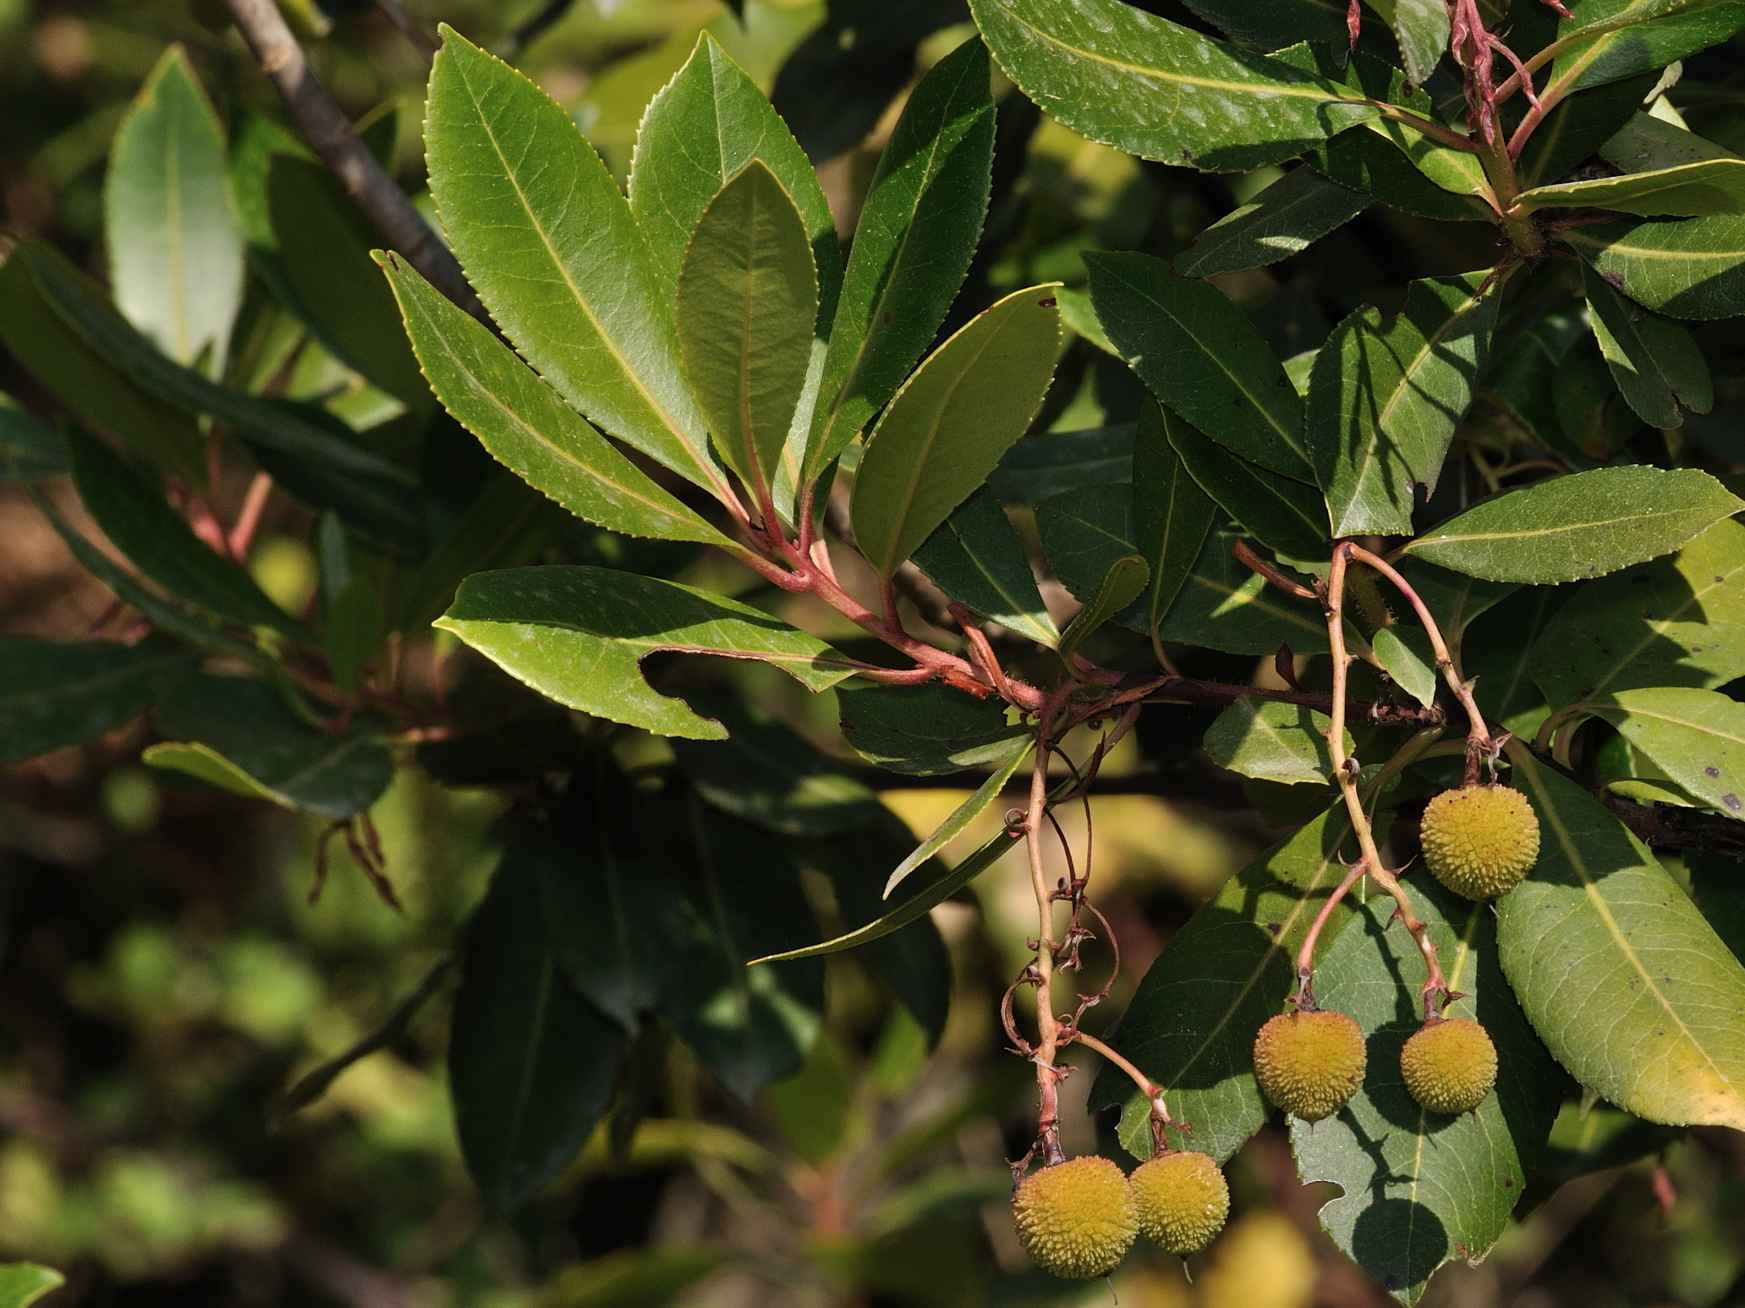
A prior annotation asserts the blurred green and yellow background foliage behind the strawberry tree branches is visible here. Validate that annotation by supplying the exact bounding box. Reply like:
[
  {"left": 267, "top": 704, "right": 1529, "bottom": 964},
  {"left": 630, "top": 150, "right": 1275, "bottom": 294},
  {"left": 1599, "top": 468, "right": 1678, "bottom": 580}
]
[{"left": 0, "top": 0, "right": 1745, "bottom": 1308}]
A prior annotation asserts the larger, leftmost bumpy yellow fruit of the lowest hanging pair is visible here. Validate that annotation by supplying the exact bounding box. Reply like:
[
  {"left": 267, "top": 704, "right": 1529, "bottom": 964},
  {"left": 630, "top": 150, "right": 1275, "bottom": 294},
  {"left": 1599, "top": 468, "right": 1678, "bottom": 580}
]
[{"left": 1012, "top": 1155, "right": 1139, "bottom": 1280}]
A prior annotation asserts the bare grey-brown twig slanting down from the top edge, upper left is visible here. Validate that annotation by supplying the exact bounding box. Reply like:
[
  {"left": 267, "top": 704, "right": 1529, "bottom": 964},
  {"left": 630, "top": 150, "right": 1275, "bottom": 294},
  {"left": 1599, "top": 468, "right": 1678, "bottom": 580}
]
[{"left": 225, "top": 0, "right": 490, "bottom": 324}]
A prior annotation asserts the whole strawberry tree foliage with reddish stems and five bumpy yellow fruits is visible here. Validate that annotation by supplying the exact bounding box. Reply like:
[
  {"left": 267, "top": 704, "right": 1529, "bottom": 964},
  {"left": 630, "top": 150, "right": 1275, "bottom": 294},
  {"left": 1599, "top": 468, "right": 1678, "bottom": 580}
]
[{"left": 10, "top": 0, "right": 1745, "bottom": 1303}]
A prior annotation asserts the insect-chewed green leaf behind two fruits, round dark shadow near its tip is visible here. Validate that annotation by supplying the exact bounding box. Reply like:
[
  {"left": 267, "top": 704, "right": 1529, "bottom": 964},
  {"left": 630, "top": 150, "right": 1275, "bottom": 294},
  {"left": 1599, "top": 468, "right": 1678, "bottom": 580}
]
[{"left": 1291, "top": 884, "right": 1564, "bottom": 1305}]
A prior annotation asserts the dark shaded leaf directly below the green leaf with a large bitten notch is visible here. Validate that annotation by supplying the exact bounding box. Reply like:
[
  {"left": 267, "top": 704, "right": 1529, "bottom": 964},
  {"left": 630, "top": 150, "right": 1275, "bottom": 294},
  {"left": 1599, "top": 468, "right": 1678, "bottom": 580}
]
[{"left": 672, "top": 708, "right": 885, "bottom": 835}]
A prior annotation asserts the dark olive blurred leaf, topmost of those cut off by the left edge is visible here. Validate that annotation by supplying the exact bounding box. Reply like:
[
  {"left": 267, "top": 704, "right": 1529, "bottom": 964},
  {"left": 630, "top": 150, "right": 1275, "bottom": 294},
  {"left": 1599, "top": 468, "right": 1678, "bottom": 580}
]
[{"left": 0, "top": 244, "right": 206, "bottom": 485}]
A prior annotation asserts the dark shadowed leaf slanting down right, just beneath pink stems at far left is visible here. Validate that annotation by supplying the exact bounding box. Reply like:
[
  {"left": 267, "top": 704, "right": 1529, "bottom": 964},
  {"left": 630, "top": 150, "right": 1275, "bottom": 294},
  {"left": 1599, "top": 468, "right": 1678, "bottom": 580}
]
[{"left": 68, "top": 433, "right": 309, "bottom": 642}]
